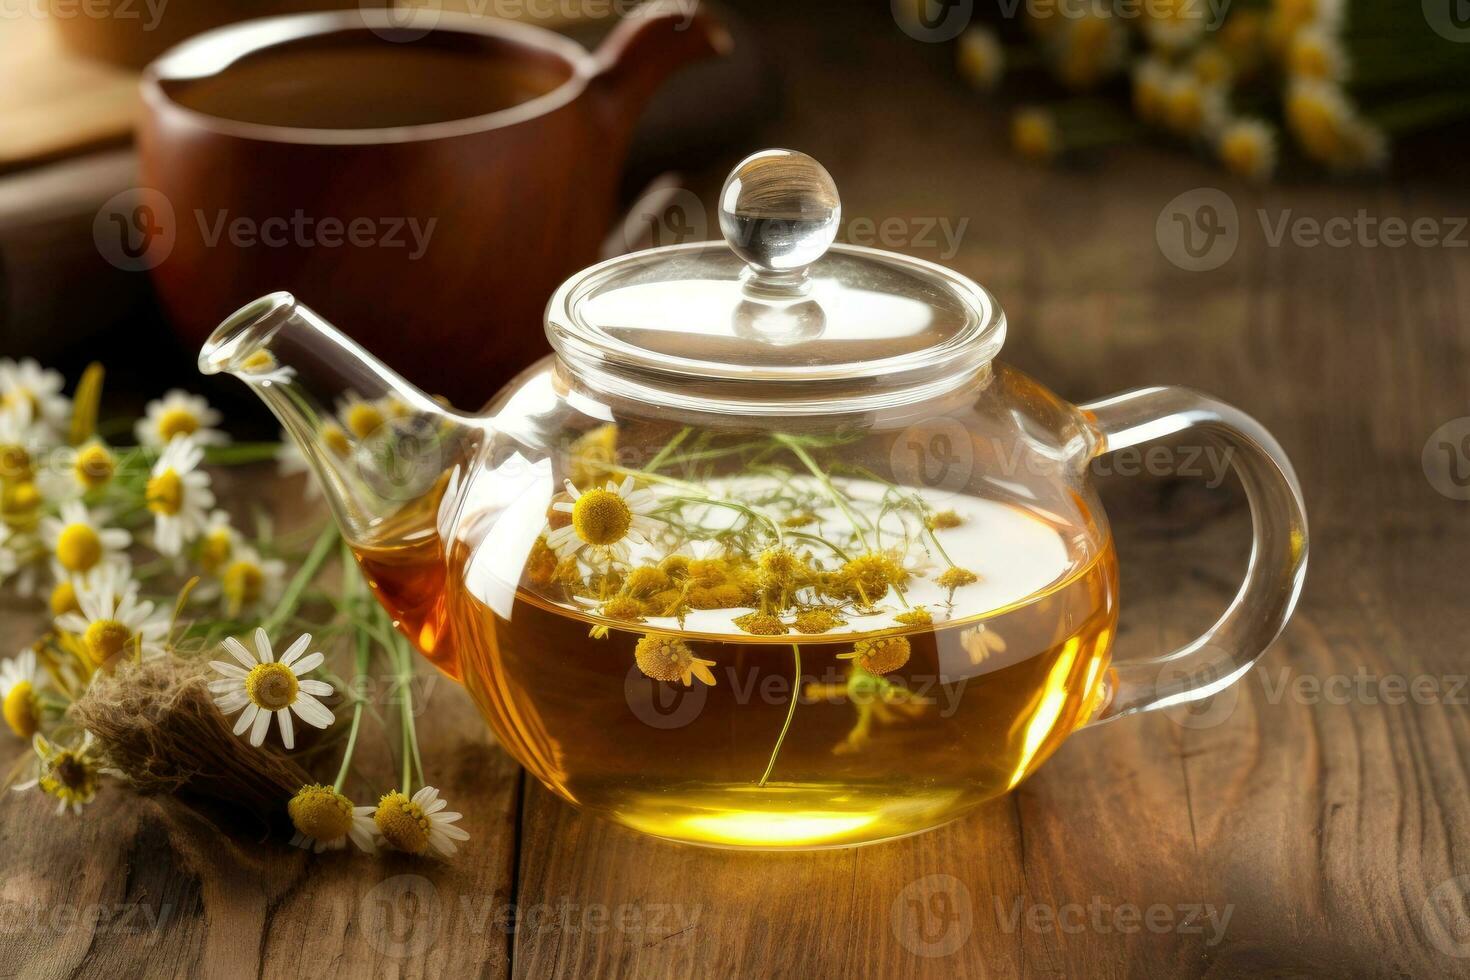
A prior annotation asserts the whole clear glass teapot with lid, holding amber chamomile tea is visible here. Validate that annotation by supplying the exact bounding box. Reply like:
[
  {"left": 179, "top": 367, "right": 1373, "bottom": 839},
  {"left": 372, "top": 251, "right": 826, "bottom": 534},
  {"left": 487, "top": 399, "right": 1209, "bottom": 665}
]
[{"left": 200, "top": 150, "right": 1307, "bottom": 848}]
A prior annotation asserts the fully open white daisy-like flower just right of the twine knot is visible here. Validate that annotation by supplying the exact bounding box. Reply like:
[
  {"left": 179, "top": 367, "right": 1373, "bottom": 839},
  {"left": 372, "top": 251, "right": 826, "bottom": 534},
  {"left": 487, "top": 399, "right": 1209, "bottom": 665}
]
[{"left": 209, "top": 629, "right": 332, "bottom": 749}]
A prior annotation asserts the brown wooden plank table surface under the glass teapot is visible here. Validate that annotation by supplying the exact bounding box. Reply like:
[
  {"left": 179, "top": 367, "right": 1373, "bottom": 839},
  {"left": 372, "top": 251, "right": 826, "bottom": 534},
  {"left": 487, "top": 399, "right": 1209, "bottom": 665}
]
[{"left": 0, "top": 4, "right": 1470, "bottom": 977}]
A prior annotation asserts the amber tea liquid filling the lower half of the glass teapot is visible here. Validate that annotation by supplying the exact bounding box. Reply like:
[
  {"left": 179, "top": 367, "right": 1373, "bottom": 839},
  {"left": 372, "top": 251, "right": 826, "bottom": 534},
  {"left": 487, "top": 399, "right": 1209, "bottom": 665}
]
[{"left": 359, "top": 484, "right": 1117, "bottom": 848}]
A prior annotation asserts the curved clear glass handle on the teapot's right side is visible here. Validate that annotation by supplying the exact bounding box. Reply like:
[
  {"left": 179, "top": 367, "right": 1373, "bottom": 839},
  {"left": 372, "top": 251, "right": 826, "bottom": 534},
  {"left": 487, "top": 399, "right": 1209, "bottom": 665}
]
[{"left": 1079, "top": 386, "right": 1307, "bottom": 724}]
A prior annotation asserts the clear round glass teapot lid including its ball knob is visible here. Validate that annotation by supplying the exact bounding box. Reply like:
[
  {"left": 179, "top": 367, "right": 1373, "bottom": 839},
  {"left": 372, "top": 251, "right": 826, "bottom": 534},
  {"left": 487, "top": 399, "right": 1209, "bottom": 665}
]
[{"left": 547, "top": 150, "right": 1005, "bottom": 413}]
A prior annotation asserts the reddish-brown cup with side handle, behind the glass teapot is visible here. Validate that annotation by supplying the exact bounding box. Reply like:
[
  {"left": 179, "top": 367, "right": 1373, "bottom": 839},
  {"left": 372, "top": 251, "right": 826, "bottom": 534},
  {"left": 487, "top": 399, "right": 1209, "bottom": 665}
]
[{"left": 140, "top": 4, "right": 728, "bottom": 406}]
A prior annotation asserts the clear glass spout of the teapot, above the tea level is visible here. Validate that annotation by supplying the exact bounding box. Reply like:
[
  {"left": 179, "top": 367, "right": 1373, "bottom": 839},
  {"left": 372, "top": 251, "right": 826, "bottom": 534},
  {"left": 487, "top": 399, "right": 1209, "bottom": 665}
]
[{"left": 198, "top": 292, "right": 482, "bottom": 551}]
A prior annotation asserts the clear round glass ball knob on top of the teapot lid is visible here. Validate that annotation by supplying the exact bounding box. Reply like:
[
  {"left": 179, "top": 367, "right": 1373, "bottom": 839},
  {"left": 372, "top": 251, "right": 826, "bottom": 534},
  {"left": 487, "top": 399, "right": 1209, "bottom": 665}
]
[{"left": 720, "top": 150, "right": 842, "bottom": 287}]
